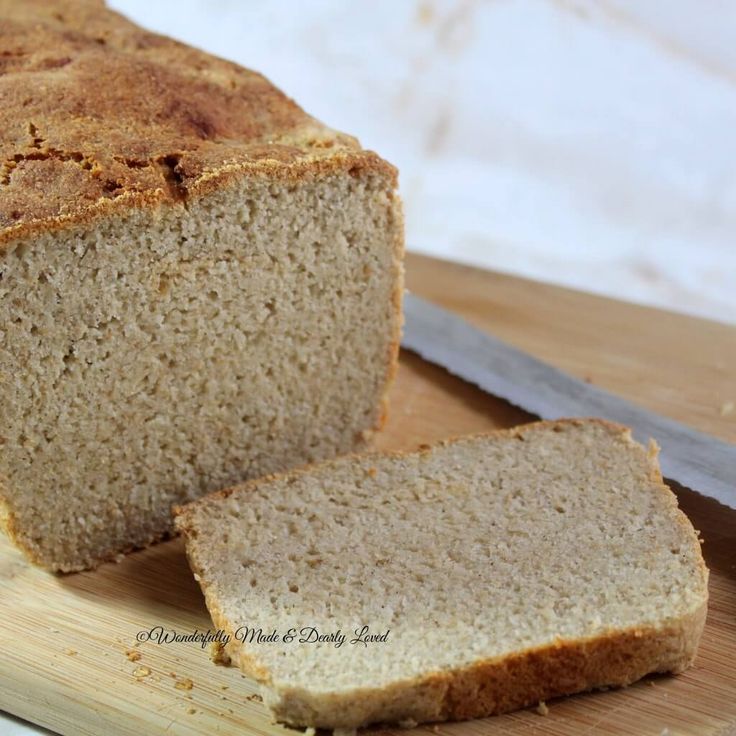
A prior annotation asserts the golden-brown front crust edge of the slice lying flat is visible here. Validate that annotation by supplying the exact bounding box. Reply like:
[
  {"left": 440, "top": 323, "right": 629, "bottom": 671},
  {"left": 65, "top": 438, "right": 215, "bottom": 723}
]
[{"left": 264, "top": 602, "right": 706, "bottom": 728}]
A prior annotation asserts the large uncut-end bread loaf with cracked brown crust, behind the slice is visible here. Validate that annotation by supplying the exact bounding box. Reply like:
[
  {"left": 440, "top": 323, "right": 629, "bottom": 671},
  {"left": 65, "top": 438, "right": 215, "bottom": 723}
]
[{"left": 0, "top": 0, "right": 403, "bottom": 571}]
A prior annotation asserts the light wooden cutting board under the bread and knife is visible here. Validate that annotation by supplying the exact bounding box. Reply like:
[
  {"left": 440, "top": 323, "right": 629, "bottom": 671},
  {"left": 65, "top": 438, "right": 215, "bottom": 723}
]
[{"left": 0, "top": 256, "right": 736, "bottom": 736}]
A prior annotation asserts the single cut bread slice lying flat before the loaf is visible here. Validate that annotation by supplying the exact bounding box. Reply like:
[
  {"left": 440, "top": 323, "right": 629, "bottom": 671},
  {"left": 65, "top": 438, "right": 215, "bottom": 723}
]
[{"left": 176, "top": 420, "right": 708, "bottom": 728}]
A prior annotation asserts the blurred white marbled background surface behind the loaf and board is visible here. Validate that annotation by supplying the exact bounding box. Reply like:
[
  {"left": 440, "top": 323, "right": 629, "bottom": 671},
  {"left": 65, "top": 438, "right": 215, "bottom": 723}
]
[{"left": 0, "top": 0, "right": 736, "bottom": 734}]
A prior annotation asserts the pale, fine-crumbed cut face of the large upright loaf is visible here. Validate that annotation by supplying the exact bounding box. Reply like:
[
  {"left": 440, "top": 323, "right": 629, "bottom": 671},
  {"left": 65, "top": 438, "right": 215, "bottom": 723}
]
[{"left": 0, "top": 172, "right": 398, "bottom": 570}]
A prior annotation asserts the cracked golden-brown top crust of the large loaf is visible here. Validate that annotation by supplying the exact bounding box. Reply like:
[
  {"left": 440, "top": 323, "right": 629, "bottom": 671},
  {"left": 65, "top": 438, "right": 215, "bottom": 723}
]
[{"left": 0, "top": 0, "right": 396, "bottom": 246}]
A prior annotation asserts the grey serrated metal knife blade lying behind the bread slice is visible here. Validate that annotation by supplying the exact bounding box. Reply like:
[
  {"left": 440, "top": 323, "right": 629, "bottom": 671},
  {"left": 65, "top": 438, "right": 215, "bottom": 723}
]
[{"left": 401, "top": 294, "right": 736, "bottom": 508}]
